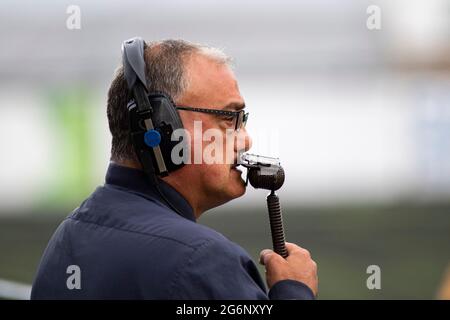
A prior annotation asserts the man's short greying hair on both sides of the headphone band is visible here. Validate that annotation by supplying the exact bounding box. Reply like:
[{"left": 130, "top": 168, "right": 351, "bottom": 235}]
[{"left": 107, "top": 40, "right": 232, "bottom": 161}]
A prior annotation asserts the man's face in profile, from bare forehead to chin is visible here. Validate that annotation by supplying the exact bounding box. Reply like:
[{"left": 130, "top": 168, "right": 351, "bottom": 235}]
[{"left": 176, "top": 55, "right": 251, "bottom": 207}]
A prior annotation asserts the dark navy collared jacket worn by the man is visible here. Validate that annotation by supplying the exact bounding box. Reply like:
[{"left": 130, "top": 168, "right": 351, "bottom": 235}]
[{"left": 31, "top": 164, "right": 314, "bottom": 299}]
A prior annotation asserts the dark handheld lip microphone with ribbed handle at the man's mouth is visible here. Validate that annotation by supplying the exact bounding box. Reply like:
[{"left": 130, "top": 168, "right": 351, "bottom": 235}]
[{"left": 238, "top": 153, "right": 288, "bottom": 258}]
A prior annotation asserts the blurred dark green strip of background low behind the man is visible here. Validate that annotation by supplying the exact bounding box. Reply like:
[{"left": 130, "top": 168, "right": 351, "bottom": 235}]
[{"left": 0, "top": 204, "right": 450, "bottom": 299}]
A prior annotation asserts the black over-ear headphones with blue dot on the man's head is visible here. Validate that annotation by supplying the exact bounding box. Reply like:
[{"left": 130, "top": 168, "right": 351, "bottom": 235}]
[{"left": 122, "top": 37, "right": 187, "bottom": 215}]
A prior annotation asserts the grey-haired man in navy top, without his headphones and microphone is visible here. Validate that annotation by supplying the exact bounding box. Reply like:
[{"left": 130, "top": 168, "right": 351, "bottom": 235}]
[{"left": 31, "top": 40, "right": 318, "bottom": 299}]
